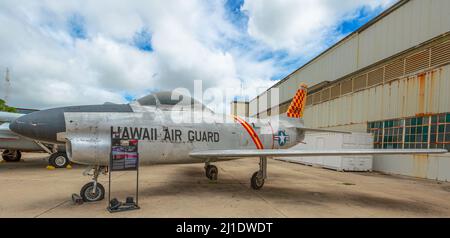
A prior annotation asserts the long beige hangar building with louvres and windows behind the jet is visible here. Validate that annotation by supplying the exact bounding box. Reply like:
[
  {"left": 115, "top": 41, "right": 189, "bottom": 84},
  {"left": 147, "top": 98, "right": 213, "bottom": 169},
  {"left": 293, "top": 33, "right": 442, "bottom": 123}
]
[{"left": 236, "top": 0, "right": 450, "bottom": 181}]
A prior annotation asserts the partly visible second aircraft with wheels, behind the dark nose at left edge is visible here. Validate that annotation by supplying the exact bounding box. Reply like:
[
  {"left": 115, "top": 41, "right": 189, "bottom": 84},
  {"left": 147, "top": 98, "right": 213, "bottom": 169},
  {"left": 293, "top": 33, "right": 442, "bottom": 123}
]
[{"left": 0, "top": 112, "right": 70, "bottom": 168}]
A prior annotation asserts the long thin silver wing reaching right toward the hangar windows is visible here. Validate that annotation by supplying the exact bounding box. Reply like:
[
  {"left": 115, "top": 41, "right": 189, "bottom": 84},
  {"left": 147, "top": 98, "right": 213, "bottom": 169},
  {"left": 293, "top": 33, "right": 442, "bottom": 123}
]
[{"left": 190, "top": 149, "right": 448, "bottom": 159}]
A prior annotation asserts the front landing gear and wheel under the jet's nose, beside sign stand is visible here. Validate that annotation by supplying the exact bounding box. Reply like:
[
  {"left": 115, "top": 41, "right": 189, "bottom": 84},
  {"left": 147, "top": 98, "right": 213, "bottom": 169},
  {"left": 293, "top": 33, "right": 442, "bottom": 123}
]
[{"left": 80, "top": 166, "right": 107, "bottom": 202}]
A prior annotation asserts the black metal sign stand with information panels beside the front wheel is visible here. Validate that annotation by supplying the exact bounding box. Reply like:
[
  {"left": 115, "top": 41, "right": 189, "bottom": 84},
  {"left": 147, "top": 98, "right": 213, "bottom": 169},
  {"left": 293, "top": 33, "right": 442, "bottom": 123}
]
[{"left": 107, "top": 128, "right": 139, "bottom": 213}]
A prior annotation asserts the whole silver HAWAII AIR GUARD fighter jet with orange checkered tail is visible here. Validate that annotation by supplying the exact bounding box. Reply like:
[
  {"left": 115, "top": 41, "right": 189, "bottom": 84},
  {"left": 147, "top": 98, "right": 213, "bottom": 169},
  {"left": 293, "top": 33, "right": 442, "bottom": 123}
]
[{"left": 10, "top": 85, "right": 447, "bottom": 202}]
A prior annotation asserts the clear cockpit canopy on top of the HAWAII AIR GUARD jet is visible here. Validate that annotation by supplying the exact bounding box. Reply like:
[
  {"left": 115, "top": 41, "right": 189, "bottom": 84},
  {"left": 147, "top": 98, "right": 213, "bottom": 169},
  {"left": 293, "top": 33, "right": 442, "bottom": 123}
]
[{"left": 137, "top": 91, "right": 211, "bottom": 111}]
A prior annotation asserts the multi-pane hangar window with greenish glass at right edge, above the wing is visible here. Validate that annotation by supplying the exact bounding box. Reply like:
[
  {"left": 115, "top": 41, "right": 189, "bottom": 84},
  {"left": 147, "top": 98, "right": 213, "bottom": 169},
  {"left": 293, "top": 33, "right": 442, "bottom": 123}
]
[{"left": 367, "top": 113, "right": 450, "bottom": 151}]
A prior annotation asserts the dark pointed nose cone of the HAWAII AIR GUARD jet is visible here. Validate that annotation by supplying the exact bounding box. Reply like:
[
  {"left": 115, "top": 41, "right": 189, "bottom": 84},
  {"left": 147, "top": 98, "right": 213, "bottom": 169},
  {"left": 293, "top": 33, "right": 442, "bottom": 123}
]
[{"left": 9, "top": 108, "right": 65, "bottom": 143}]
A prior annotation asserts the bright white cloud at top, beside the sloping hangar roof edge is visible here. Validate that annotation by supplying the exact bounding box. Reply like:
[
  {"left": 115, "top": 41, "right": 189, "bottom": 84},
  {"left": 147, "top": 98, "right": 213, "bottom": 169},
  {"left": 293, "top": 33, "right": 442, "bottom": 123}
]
[{"left": 242, "top": 0, "right": 395, "bottom": 55}]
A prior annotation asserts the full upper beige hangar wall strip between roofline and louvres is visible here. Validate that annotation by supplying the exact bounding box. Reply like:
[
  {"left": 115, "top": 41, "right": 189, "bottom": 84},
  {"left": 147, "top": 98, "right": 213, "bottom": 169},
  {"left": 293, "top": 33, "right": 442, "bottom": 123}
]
[{"left": 250, "top": 0, "right": 450, "bottom": 116}]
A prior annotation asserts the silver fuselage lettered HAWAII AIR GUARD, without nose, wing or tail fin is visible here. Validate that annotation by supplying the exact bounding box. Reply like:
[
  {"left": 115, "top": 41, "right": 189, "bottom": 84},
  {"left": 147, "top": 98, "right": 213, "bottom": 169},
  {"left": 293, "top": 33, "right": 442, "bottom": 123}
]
[{"left": 62, "top": 104, "right": 304, "bottom": 165}]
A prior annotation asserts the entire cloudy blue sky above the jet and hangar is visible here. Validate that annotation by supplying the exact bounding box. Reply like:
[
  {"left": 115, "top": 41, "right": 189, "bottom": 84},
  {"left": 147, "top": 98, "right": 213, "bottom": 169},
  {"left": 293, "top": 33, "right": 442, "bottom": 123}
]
[{"left": 0, "top": 0, "right": 395, "bottom": 110}]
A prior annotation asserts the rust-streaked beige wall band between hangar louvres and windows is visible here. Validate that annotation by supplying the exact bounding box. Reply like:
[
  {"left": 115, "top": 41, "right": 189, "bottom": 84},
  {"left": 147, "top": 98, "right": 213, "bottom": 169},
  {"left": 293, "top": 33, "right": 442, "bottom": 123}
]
[{"left": 304, "top": 65, "right": 450, "bottom": 131}]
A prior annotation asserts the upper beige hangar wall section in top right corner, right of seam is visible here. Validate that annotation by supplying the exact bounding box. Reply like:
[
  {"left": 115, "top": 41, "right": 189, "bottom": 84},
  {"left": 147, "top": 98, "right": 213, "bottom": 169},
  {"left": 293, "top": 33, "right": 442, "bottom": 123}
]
[{"left": 358, "top": 0, "right": 450, "bottom": 69}]
